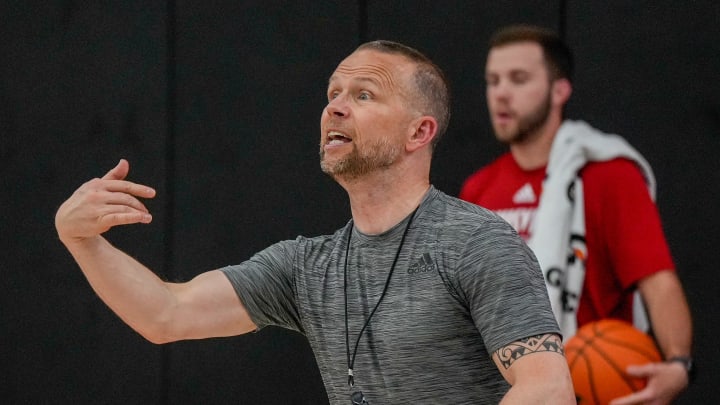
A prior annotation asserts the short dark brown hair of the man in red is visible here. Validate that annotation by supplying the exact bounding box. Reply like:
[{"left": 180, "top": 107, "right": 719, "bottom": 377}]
[{"left": 490, "top": 24, "right": 574, "bottom": 82}]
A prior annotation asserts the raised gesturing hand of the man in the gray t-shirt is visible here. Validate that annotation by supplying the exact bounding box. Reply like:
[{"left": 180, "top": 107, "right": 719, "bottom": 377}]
[{"left": 55, "top": 159, "right": 155, "bottom": 243}]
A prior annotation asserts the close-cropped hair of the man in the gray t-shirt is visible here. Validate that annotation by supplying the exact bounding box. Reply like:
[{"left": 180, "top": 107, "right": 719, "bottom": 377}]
[{"left": 356, "top": 40, "right": 450, "bottom": 147}]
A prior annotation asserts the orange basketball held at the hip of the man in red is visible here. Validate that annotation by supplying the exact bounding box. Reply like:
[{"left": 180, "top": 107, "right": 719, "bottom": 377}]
[{"left": 565, "top": 319, "right": 662, "bottom": 405}]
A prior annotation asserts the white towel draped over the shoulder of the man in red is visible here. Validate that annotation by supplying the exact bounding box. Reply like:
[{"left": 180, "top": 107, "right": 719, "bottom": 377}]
[{"left": 528, "top": 120, "right": 655, "bottom": 340}]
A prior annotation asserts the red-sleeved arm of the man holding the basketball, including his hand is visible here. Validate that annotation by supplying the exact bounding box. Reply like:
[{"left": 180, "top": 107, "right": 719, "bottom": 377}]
[{"left": 586, "top": 159, "right": 692, "bottom": 405}]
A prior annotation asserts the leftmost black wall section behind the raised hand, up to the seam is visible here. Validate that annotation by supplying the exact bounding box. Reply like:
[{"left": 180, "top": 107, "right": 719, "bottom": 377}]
[{"left": 0, "top": 1, "right": 166, "bottom": 403}]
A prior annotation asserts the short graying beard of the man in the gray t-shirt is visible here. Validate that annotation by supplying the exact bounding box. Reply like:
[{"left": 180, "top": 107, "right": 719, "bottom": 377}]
[{"left": 320, "top": 138, "right": 400, "bottom": 180}]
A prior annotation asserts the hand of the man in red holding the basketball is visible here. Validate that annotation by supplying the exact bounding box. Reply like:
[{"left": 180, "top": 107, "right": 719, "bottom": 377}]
[{"left": 610, "top": 362, "right": 689, "bottom": 405}]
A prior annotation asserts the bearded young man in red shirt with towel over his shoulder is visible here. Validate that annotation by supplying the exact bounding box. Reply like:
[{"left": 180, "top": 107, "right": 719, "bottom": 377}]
[{"left": 460, "top": 25, "right": 692, "bottom": 405}]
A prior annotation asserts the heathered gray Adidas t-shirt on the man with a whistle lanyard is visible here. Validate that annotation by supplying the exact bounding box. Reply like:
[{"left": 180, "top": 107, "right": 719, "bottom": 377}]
[{"left": 223, "top": 188, "right": 559, "bottom": 405}]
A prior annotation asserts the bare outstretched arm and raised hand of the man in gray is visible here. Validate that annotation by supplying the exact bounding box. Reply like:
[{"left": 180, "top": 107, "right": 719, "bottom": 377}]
[{"left": 55, "top": 160, "right": 255, "bottom": 343}]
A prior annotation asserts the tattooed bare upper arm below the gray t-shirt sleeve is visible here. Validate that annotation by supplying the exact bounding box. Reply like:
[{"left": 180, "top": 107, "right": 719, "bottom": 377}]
[{"left": 493, "top": 334, "right": 576, "bottom": 405}]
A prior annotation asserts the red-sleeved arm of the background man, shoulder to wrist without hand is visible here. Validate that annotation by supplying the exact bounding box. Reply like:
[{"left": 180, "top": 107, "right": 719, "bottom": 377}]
[{"left": 586, "top": 160, "right": 692, "bottom": 358}]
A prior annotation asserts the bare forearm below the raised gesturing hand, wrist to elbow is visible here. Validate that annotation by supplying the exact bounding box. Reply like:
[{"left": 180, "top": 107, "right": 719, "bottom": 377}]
[{"left": 65, "top": 236, "right": 175, "bottom": 343}]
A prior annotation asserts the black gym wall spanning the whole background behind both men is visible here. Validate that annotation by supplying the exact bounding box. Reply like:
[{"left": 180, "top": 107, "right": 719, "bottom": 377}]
[{"left": 0, "top": 0, "right": 720, "bottom": 404}]
